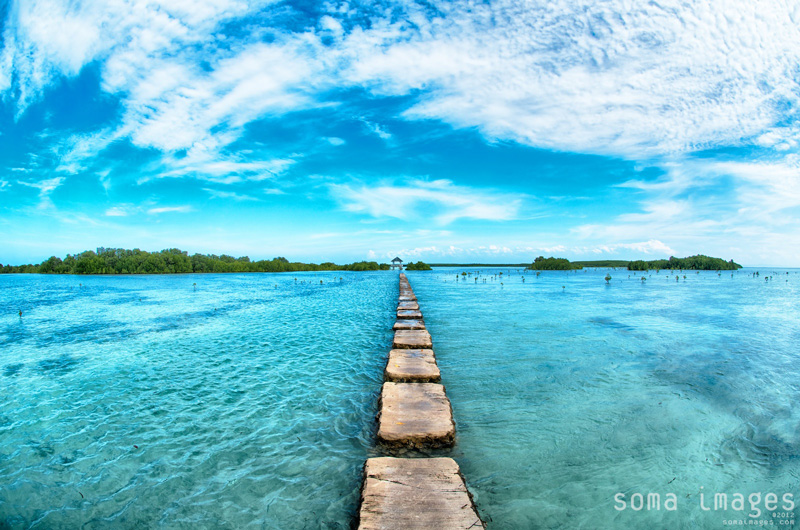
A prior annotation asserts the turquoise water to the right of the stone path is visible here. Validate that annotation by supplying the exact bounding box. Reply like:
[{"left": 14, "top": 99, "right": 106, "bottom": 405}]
[{"left": 408, "top": 269, "right": 800, "bottom": 529}]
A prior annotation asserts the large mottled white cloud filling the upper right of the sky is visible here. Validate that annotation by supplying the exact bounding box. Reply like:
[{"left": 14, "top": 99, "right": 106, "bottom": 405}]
[{"left": 343, "top": 0, "right": 800, "bottom": 158}]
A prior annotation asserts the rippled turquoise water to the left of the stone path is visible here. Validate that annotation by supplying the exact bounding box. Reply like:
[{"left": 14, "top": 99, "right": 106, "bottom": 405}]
[{"left": 0, "top": 273, "right": 397, "bottom": 529}]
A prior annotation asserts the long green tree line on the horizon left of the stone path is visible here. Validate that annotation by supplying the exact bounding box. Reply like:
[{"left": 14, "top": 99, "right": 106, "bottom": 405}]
[{"left": 0, "top": 247, "right": 390, "bottom": 274}]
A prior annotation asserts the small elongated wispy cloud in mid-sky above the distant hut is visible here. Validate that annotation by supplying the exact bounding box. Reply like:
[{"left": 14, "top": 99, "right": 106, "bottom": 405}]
[{"left": 330, "top": 179, "right": 522, "bottom": 224}]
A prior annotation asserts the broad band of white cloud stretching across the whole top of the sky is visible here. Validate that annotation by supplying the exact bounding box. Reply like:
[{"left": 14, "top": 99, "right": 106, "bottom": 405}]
[{"left": 6, "top": 0, "right": 800, "bottom": 165}]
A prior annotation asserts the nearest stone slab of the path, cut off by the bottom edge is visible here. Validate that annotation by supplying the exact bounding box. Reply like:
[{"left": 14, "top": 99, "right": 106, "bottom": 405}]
[{"left": 358, "top": 457, "right": 485, "bottom": 530}]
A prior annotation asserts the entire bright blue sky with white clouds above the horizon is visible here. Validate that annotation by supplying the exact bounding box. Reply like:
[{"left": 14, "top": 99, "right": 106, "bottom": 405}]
[{"left": 0, "top": 0, "right": 800, "bottom": 266}]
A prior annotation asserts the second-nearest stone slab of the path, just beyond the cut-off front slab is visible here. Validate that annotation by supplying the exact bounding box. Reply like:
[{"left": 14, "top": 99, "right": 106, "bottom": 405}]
[{"left": 378, "top": 382, "right": 456, "bottom": 449}]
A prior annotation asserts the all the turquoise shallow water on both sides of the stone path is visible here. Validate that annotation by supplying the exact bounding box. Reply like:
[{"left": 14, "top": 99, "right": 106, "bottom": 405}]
[{"left": 0, "top": 269, "right": 800, "bottom": 529}]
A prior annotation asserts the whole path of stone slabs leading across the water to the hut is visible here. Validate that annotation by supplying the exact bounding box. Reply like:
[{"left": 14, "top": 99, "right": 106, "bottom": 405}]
[{"left": 359, "top": 273, "right": 484, "bottom": 530}]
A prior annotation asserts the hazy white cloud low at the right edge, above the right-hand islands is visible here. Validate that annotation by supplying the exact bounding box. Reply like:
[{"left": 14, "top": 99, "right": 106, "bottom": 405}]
[{"left": 571, "top": 155, "right": 800, "bottom": 264}]
